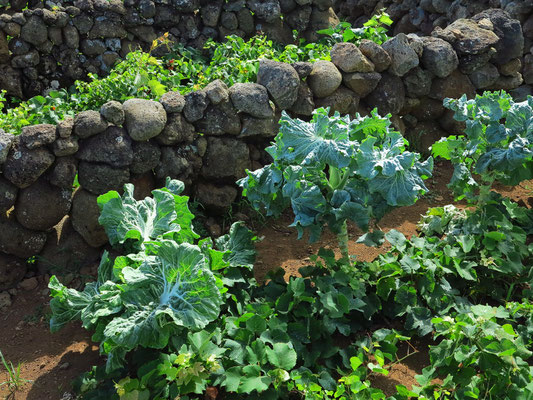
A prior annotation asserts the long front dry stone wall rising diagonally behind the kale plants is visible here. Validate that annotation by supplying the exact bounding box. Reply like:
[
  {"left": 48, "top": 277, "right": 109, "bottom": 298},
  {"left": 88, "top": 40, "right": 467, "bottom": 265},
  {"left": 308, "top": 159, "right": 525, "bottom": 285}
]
[{"left": 0, "top": 7, "right": 522, "bottom": 291}]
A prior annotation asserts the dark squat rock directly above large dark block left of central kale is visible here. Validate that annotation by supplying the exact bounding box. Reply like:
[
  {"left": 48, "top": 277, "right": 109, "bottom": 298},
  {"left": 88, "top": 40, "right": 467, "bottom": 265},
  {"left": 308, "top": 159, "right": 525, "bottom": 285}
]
[{"left": 196, "top": 100, "right": 241, "bottom": 135}]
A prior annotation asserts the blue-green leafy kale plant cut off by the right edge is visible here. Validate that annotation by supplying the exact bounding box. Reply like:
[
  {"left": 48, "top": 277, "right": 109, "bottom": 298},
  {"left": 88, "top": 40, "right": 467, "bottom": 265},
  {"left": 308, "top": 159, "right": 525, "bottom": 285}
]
[{"left": 432, "top": 91, "right": 533, "bottom": 204}]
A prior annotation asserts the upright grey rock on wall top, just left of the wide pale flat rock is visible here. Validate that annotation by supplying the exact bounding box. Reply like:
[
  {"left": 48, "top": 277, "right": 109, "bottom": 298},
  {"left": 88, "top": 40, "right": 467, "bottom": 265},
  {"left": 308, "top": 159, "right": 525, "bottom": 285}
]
[{"left": 421, "top": 37, "right": 459, "bottom": 78}]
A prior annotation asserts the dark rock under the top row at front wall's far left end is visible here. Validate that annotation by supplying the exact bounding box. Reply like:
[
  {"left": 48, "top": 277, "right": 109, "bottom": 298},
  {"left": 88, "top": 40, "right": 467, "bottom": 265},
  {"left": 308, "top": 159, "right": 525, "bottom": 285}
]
[{"left": 3, "top": 143, "right": 55, "bottom": 189}]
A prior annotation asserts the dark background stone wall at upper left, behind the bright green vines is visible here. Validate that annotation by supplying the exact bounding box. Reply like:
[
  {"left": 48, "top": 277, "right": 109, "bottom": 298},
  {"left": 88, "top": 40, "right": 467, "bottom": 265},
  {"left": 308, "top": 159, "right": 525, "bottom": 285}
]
[{"left": 0, "top": 0, "right": 338, "bottom": 98}]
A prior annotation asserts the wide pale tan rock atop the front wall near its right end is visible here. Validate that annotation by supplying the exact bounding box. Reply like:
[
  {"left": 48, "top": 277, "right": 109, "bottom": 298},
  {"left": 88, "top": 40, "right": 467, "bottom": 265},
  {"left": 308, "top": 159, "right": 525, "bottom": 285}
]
[{"left": 432, "top": 18, "right": 500, "bottom": 54}]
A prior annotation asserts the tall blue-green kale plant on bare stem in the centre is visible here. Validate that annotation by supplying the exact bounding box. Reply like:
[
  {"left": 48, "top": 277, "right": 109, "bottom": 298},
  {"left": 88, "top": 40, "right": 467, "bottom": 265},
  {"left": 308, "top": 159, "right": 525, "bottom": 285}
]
[{"left": 238, "top": 108, "right": 433, "bottom": 260}]
